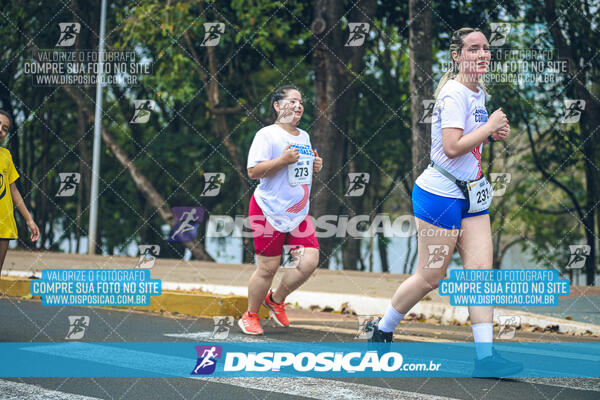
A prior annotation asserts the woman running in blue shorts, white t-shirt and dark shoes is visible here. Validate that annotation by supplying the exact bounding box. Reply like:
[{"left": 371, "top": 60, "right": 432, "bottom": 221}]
[{"left": 371, "top": 28, "right": 522, "bottom": 376}]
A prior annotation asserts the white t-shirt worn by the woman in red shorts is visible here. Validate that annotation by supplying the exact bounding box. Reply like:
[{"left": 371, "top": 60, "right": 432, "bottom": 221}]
[{"left": 248, "top": 124, "right": 314, "bottom": 232}]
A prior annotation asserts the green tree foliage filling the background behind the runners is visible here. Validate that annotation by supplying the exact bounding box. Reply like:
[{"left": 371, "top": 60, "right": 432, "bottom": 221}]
[{"left": 0, "top": 0, "right": 600, "bottom": 282}]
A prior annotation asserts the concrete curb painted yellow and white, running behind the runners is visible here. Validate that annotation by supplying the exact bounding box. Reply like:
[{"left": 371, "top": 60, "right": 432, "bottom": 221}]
[{"left": 0, "top": 271, "right": 600, "bottom": 335}]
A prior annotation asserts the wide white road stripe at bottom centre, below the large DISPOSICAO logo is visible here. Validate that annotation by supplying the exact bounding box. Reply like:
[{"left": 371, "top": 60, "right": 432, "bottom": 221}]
[{"left": 193, "top": 377, "right": 455, "bottom": 400}]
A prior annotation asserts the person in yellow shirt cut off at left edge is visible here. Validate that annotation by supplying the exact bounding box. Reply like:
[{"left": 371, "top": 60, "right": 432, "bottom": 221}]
[{"left": 0, "top": 110, "right": 40, "bottom": 272}]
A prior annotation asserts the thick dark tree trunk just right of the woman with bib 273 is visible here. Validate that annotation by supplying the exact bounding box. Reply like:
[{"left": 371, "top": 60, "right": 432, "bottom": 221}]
[{"left": 310, "top": 0, "right": 377, "bottom": 268}]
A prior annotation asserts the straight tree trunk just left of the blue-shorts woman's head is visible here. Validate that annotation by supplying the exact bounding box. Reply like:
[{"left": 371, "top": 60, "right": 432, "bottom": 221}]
[{"left": 408, "top": 0, "right": 433, "bottom": 182}]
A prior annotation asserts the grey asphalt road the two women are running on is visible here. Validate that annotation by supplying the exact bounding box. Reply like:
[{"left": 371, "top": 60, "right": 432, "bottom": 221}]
[{"left": 0, "top": 297, "right": 600, "bottom": 400}]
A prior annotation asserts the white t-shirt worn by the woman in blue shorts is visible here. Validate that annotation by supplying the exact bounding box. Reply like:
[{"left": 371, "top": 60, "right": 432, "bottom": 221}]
[{"left": 415, "top": 79, "right": 488, "bottom": 199}]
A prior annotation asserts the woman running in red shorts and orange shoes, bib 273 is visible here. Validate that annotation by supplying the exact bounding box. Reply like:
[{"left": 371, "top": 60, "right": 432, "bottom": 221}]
[{"left": 238, "top": 85, "right": 323, "bottom": 335}]
